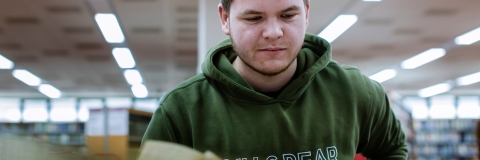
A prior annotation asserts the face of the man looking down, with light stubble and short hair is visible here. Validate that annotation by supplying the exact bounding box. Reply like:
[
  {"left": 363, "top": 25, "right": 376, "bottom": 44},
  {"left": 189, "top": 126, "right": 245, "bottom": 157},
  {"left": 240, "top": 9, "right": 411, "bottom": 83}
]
[{"left": 219, "top": 0, "right": 309, "bottom": 76}]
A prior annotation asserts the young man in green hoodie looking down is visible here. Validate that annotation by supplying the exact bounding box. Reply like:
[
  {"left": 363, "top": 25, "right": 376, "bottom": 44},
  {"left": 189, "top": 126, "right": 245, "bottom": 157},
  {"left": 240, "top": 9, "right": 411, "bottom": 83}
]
[{"left": 143, "top": 0, "right": 407, "bottom": 160}]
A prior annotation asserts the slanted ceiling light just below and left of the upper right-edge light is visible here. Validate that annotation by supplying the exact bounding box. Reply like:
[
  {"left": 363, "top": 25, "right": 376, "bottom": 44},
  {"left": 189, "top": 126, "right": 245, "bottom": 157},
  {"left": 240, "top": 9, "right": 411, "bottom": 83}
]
[{"left": 401, "top": 48, "right": 446, "bottom": 69}]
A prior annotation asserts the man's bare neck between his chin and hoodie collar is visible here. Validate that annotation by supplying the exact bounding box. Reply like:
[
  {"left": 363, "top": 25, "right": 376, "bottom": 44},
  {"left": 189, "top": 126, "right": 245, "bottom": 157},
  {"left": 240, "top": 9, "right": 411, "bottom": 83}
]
[{"left": 233, "top": 57, "right": 297, "bottom": 92}]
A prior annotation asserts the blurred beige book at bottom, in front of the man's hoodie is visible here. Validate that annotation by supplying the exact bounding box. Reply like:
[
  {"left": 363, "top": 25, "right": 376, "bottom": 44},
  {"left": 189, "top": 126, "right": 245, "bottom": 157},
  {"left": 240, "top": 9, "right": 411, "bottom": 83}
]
[{"left": 138, "top": 140, "right": 221, "bottom": 160}]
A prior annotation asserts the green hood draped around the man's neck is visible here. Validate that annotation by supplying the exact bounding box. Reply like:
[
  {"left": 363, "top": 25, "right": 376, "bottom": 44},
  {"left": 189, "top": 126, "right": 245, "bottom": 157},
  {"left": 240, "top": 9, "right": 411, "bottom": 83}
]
[{"left": 202, "top": 34, "right": 332, "bottom": 104}]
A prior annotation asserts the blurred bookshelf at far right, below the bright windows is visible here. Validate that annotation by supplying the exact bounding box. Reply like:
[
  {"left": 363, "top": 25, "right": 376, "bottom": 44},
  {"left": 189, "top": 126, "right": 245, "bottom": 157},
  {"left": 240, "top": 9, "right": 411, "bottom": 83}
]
[{"left": 412, "top": 119, "right": 478, "bottom": 159}]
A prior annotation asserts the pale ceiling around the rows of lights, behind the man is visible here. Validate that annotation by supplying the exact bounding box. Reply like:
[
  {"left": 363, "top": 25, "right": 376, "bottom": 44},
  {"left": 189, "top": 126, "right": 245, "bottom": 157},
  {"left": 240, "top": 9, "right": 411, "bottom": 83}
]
[{"left": 0, "top": 0, "right": 480, "bottom": 98}]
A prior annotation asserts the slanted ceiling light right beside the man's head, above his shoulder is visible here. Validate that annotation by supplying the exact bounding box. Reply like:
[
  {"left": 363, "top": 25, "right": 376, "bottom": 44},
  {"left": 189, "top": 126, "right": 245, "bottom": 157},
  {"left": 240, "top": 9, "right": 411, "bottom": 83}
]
[{"left": 318, "top": 15, "right": 358, "bottom": 43}]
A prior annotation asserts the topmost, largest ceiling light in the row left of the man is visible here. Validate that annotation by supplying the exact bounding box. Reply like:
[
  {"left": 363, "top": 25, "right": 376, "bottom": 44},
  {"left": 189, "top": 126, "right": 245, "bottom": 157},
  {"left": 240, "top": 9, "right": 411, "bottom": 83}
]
[{"left": 95, "top": 13, "right": 125, "bottom": 43}]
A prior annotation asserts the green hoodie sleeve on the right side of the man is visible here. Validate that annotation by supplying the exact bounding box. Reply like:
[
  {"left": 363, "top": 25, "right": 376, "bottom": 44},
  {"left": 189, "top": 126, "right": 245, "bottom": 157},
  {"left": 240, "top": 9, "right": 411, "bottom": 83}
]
[{"left": 358, "top": 80, "right": 407, "bottom": 160}]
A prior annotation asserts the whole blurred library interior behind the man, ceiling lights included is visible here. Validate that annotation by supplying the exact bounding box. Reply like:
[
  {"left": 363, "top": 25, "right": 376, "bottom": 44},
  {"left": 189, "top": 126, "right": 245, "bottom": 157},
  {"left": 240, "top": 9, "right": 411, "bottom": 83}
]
[{"left": 0, "top": 0, "right": 480, "bottom": 160}]
